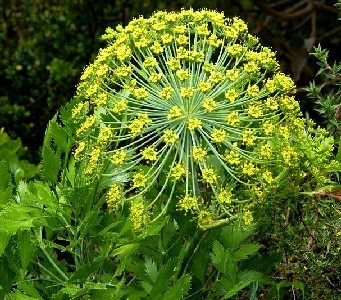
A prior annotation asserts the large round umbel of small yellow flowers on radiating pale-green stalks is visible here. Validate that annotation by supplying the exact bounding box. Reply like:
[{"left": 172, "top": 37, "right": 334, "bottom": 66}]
[{"left": 72, "top": 10, "right": 304, "bottom": 229}]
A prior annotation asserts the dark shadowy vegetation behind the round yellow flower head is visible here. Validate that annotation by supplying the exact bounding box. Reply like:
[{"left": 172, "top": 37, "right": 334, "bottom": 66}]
[{"left": 0, "top": 0, "right": 341, "bottom": 163}]
